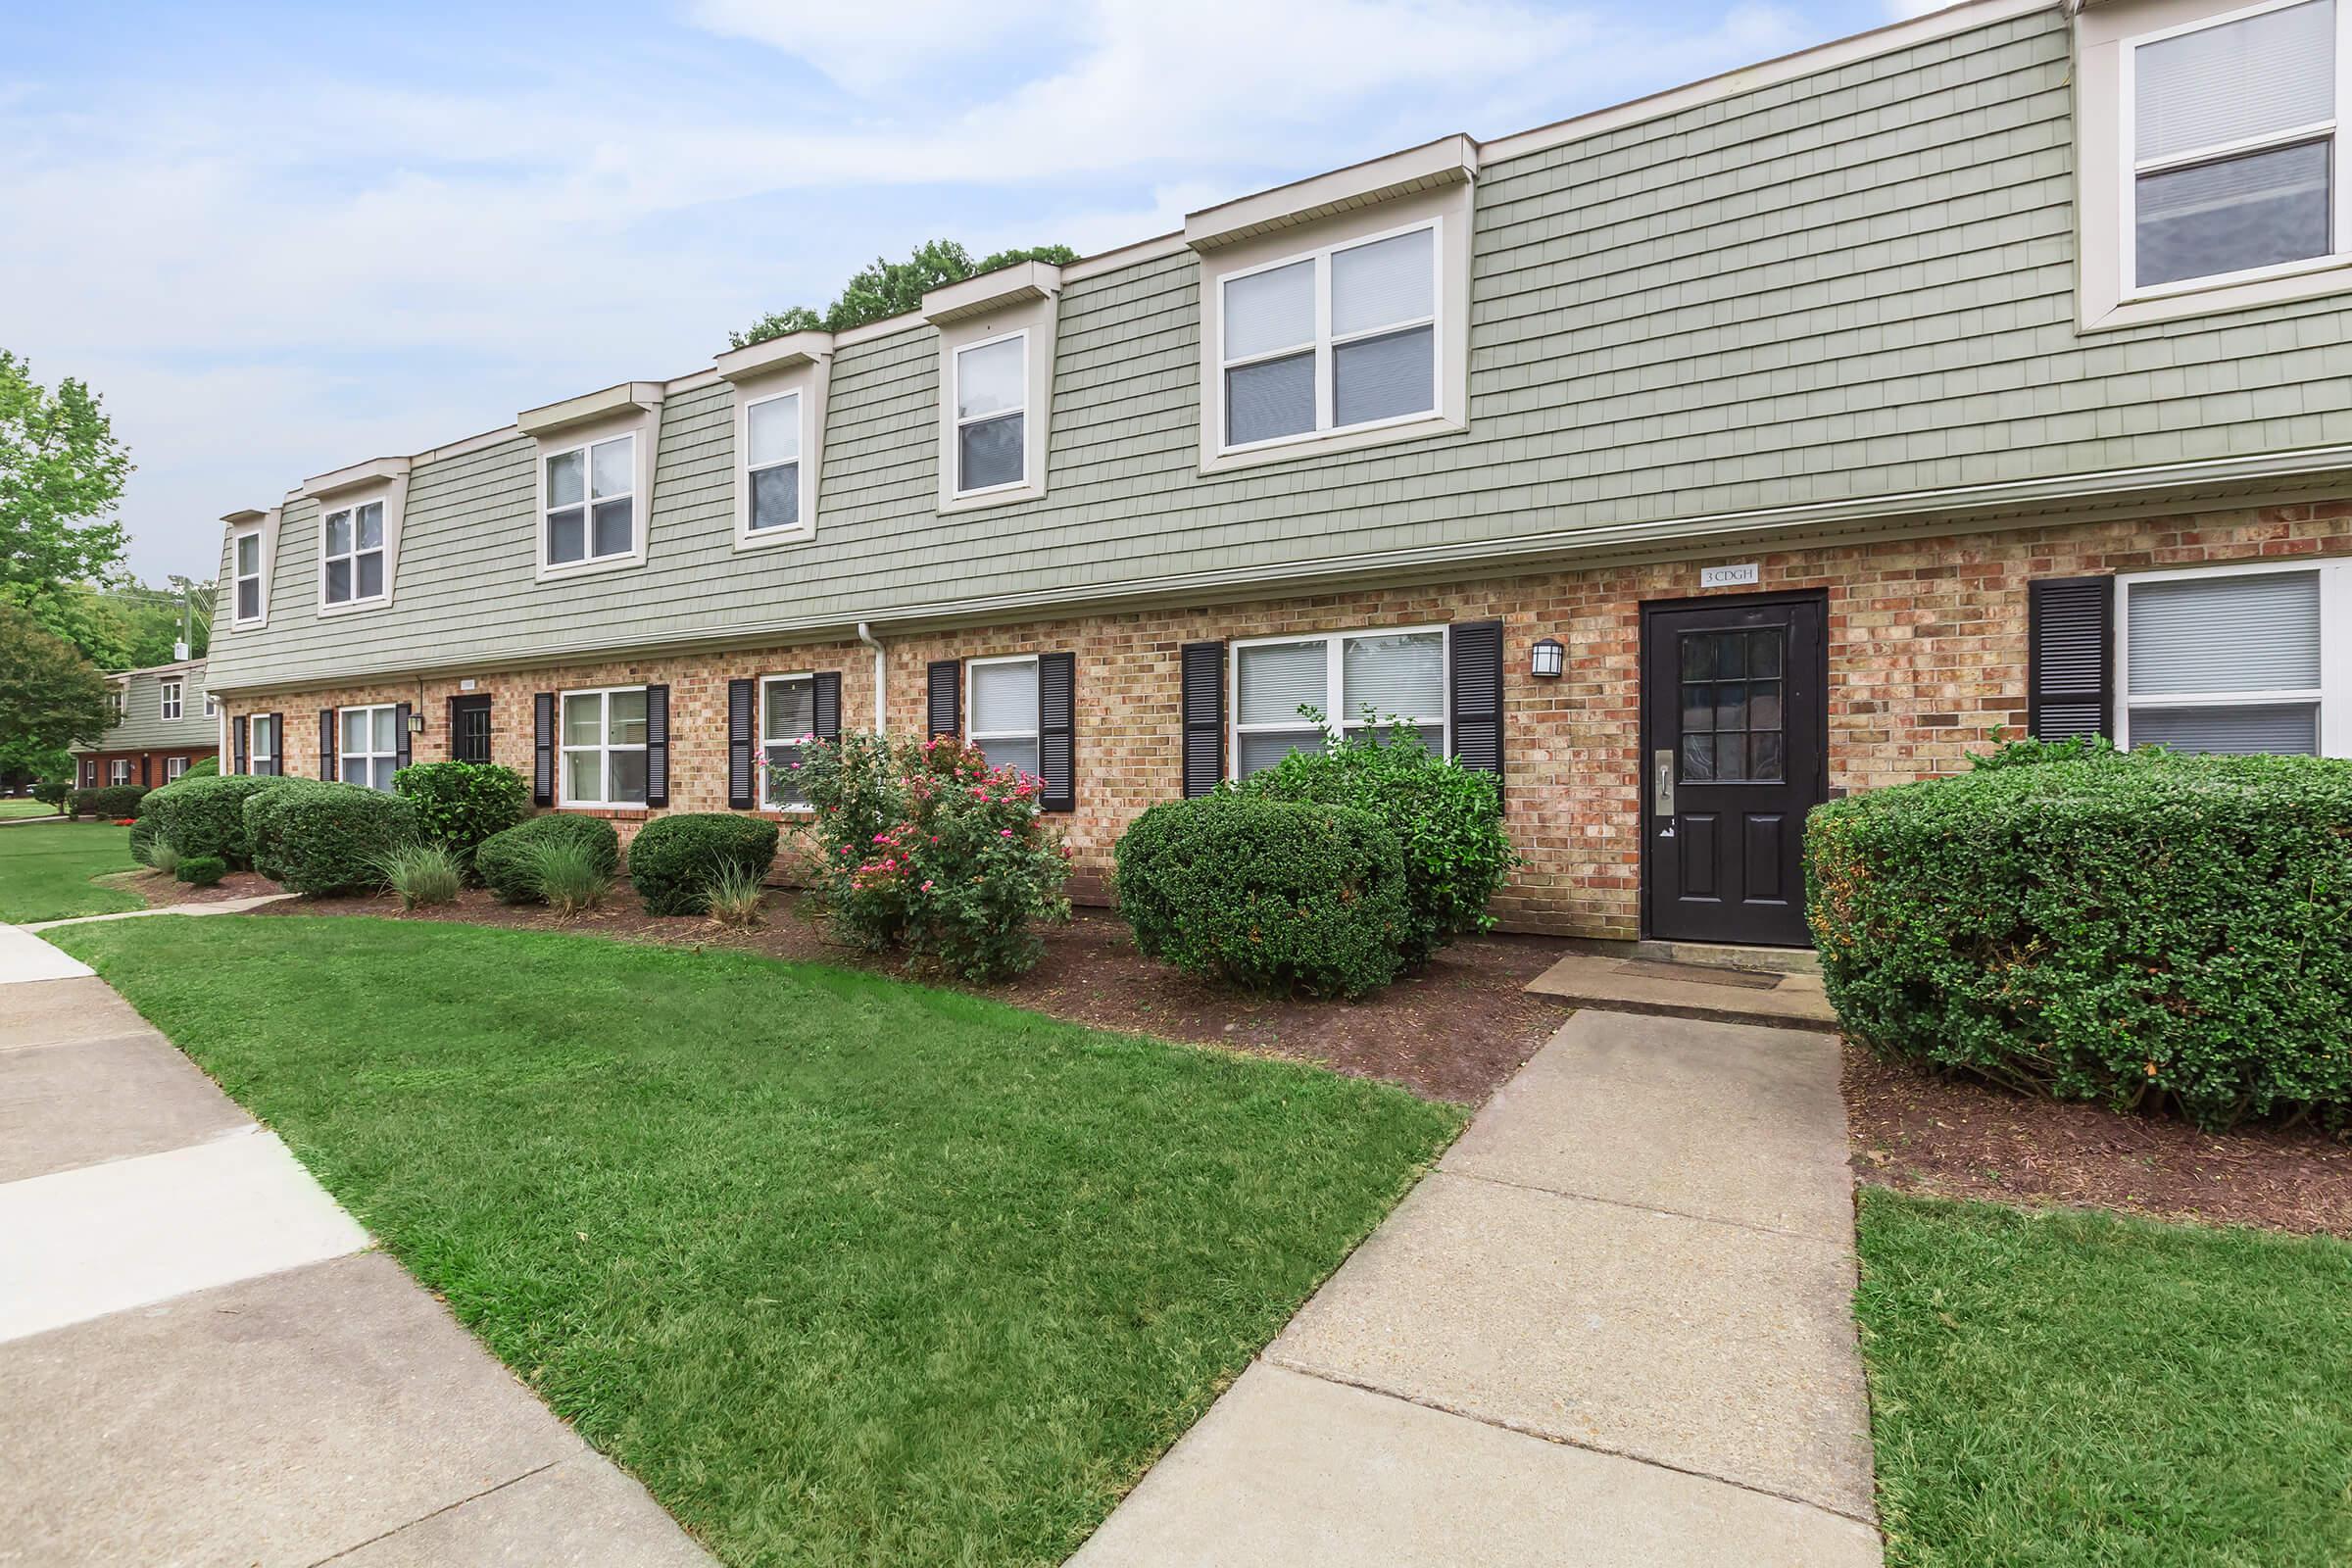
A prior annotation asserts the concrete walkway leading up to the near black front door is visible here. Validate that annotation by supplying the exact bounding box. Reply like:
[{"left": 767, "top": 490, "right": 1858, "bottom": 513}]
[{"left": 1072, "top": 1010, "right": 1880, "bottom": 1568}]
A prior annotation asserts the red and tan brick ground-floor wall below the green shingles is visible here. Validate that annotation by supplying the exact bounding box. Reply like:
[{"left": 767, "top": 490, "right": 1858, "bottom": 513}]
[{"left": 230, "top": 501, "right": 2352, "bottom": 936}]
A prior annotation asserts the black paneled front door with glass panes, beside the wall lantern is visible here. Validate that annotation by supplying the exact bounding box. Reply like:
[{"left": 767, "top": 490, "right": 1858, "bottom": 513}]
[{"left": 1642, "top": 595, "right": 1830, "bottom": 948}]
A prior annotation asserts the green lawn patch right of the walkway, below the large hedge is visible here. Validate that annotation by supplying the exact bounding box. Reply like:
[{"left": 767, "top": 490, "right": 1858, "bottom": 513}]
[{"left": 1858, "top": 1190, "right": 2352, "bottom": 1568}]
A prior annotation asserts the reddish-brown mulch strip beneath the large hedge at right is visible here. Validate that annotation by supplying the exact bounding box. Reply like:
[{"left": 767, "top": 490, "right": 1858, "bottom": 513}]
[{"left": 1844, "top": 1046, "right": 2352, "bottom": 1237}]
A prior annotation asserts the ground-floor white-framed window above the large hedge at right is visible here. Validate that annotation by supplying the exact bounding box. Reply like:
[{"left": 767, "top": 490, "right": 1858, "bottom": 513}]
[{"left": 2117, "top": 562, "right": 2352, "bottom": 757}]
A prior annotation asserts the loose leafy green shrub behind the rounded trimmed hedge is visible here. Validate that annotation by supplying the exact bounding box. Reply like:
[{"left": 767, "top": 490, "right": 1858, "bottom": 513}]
[{"left": 1237, "top": 729, "right": 1515, "bottom": 971}]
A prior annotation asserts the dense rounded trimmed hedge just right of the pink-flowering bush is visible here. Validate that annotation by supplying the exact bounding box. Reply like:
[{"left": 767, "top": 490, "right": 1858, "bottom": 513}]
[{"left": 1115, "top": 795, "right": 1413, "bottom": 997}]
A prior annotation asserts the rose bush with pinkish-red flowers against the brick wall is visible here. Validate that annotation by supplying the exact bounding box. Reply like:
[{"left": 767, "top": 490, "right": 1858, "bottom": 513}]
[{"left": 800, "top": 733, "right": 1070, "bottom": 980}]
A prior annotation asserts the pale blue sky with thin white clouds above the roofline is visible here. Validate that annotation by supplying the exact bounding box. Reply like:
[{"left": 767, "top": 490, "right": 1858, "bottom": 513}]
[{"left": 0, "top": 0, "right": 1929, "bottom": 578}]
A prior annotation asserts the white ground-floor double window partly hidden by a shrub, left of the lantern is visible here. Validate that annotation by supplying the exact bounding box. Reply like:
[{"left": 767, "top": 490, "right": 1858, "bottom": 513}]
[{"left": 1233, "top": 627, "right": 1446, "bottom": 778}]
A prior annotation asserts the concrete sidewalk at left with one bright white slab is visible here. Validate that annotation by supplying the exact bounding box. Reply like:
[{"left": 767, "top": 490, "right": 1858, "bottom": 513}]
[{"left": 0, "top": 921, "right": 710, "bottom": 1568}]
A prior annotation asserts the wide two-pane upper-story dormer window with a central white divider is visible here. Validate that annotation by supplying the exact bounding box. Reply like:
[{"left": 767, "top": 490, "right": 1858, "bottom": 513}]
[{"left": 1221, "top": 220, "right": 1437, "bottom": 452}]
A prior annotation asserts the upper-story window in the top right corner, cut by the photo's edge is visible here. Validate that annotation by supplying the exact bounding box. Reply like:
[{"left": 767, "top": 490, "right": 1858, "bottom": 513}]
[{"left": 2127, "top": 0, "right": 2345, "bottom": 289}]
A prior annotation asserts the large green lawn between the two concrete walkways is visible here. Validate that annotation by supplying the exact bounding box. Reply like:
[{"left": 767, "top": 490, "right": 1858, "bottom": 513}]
[{"left": 61, "top": 917, "right": 1460, "bottom": 1566}]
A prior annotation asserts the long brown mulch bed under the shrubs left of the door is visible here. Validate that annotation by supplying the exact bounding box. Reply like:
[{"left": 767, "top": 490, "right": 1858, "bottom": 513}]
[{"left": 257, "top": 884, "right": 1569, "bottom": 1104}]
